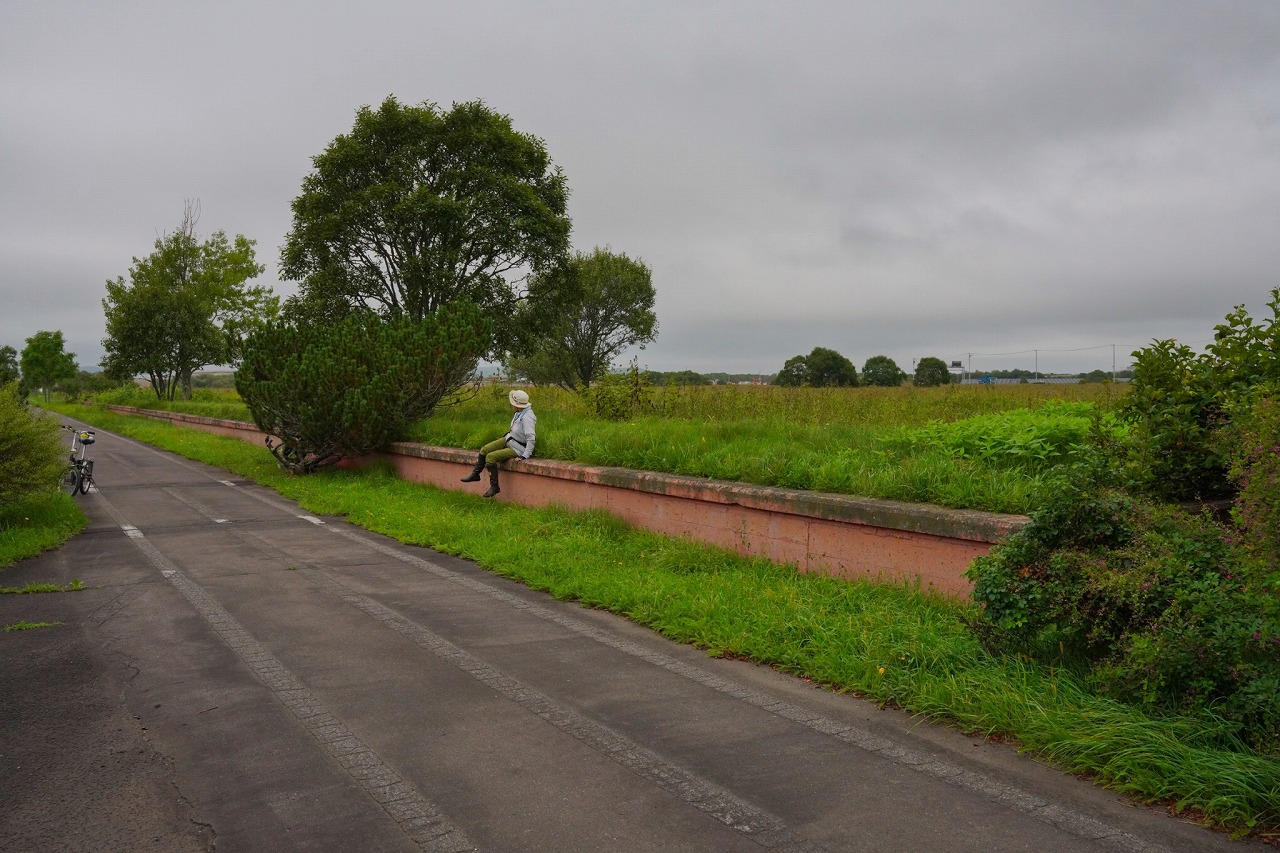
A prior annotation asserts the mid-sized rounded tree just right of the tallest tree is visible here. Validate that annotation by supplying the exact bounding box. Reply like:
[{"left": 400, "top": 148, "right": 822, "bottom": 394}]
[{"left": 508, "top": 248, "right": 658, "bottom": 391}]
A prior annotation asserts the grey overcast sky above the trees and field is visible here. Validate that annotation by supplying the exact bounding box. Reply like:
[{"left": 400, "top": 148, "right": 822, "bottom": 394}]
[{"left": 0, "top": 0, "right": 1280, "bottom": 373}]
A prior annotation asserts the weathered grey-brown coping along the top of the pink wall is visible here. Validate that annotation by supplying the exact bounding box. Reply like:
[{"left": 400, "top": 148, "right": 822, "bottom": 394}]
[{"left": 106, "top": 405, "right": 1028, "bottom": 543}]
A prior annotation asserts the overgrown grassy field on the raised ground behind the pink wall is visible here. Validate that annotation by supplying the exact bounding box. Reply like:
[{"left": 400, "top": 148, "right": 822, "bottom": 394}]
[{"left": 99, "top": 384, "right": 1123, "bottom": 514}]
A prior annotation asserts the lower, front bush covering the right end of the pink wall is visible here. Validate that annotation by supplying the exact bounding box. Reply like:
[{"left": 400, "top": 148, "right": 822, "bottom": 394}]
[{"left": 968, "top": 470, "right": 1280, "bottom": 752}]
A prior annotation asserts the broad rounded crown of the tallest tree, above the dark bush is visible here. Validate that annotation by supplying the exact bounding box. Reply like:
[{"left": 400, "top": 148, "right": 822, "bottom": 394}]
[{"left": 280, "top": 97, "right": 570, "bottom": 351}]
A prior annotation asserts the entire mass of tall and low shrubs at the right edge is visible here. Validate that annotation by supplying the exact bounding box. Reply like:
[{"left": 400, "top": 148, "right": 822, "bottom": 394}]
[{"left": 969, "top": 288, "right": 1280, "bottom": 768}]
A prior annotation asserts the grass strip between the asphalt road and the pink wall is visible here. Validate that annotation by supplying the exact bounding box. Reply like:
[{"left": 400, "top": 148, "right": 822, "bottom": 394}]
[{"left": 45, "top": 407, "right": 1280, "bottom": 831}]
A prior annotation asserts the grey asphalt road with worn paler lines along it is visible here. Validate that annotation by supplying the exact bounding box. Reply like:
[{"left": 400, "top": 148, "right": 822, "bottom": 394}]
[{"left": 0, "top": 417, "right": 1253, "bottom": 853}]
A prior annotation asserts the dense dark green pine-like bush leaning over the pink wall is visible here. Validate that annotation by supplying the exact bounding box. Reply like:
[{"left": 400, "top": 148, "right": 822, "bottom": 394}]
[{"left": 236, "top": 304, "right": 489, "bottom": 474}]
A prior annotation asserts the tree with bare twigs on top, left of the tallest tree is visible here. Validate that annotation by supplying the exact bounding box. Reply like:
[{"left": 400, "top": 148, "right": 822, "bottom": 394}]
[{"left": 102, "top": 205, "right": 279, "bottom": 400}]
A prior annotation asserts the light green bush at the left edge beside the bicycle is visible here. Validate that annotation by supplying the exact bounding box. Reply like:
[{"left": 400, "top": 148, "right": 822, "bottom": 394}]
[{"left": 0, "top": 382, "right": 68, "bottom": 507}]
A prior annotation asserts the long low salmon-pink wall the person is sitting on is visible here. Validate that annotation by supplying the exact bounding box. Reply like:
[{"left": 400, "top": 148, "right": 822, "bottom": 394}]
[{"left": 109, "top": 406, "right": 1027, "bottom": 596}]
